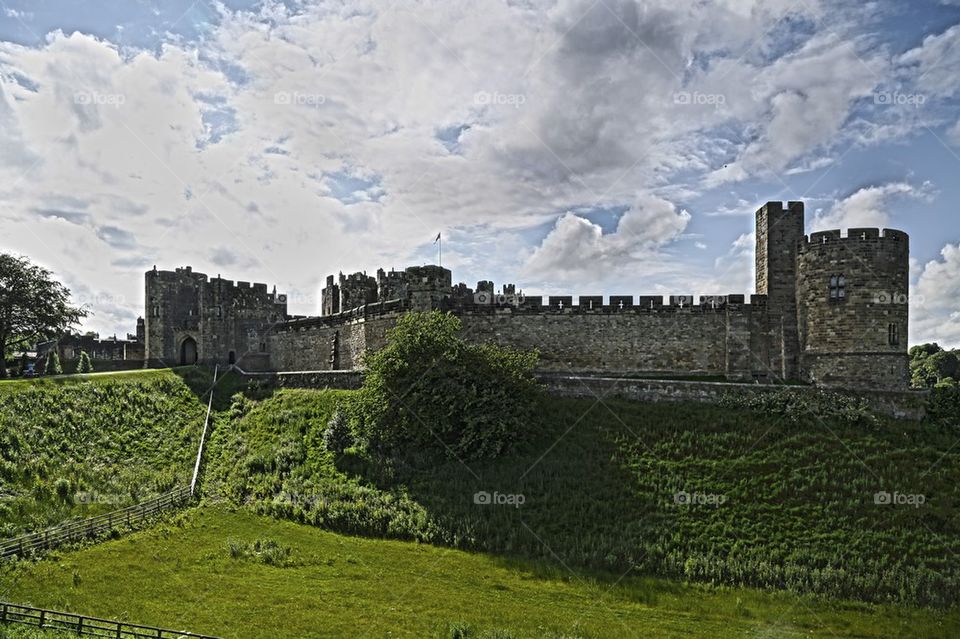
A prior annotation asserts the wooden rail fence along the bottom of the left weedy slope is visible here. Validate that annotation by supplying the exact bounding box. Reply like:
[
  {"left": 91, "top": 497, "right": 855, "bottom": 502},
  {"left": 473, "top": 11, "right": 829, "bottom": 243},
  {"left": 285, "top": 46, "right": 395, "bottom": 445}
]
[{"left": 0, "top": 486, "right": 192, "bottom": 560}]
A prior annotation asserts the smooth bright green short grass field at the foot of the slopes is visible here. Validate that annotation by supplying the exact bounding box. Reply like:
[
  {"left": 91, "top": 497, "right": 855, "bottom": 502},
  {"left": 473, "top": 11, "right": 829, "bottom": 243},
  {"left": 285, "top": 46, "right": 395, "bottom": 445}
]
[{"left": 0, "top": 507, "right": 960, "bottom": 639}]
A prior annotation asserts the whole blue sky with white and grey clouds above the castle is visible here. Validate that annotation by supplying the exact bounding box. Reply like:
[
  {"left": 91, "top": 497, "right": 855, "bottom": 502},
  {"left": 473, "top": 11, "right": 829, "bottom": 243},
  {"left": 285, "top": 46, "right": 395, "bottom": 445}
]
[{"left": 0, "top": 0, "right": 960, "bottom": 346}]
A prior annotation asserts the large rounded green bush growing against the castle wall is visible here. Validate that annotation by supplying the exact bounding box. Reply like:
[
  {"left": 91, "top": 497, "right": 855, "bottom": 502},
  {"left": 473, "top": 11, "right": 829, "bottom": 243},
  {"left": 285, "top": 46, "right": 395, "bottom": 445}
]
[{"left": 350, "top": 311, "right": 539, "bottom": 459}]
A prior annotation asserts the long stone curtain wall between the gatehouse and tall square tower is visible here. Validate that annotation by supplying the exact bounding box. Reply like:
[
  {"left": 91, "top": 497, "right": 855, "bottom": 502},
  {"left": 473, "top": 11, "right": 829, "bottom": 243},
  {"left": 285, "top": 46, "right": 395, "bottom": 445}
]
[{"left": 268, "top": 298, "right": 767, "bottom": 379}]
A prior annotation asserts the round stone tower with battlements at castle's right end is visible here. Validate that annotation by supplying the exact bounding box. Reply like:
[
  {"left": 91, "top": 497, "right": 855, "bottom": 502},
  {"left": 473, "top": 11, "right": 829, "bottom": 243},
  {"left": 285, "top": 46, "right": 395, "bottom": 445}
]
[{"left": 797, "top": 228, "right": 910, "bottom": 390}]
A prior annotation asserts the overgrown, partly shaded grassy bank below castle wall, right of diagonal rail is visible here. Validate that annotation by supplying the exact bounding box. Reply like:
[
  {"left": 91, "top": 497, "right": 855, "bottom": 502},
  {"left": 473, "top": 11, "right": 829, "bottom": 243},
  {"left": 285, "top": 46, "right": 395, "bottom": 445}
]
[{"left": 208, "top": 390, "right": 960, "bottom": 605}]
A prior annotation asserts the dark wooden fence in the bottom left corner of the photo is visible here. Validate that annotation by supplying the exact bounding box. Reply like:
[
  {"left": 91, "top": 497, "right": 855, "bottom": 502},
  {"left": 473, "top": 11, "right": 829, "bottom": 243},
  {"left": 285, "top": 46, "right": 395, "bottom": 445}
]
[{"left": 0, "top": 602, "right": 217, "bottom": 639}]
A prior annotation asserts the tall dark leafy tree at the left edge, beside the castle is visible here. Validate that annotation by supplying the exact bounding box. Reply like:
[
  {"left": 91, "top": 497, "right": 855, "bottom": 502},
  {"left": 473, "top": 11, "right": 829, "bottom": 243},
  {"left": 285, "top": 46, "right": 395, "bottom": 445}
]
[{"left": 0, "top": 253, "right": 87, "bottom": 377}]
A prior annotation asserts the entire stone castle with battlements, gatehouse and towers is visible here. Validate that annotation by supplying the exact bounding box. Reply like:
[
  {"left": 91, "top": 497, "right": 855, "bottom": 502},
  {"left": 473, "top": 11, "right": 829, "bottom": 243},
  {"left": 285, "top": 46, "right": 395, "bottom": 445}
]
[{"left": 145, "top": 202, "right": 909, "bottom": 390}]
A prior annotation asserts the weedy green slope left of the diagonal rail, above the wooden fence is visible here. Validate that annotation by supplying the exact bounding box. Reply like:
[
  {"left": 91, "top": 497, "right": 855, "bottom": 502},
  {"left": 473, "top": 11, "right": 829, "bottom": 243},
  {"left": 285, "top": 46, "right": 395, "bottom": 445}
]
[{"left": 0, "top": 370, "right": 209, "bottom": 537}]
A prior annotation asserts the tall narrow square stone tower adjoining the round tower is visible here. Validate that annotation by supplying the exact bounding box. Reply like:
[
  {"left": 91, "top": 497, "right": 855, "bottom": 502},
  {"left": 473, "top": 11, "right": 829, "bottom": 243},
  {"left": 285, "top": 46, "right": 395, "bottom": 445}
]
[{"left": 754, "top": 202, "right": 804, "bottom": 380}]
